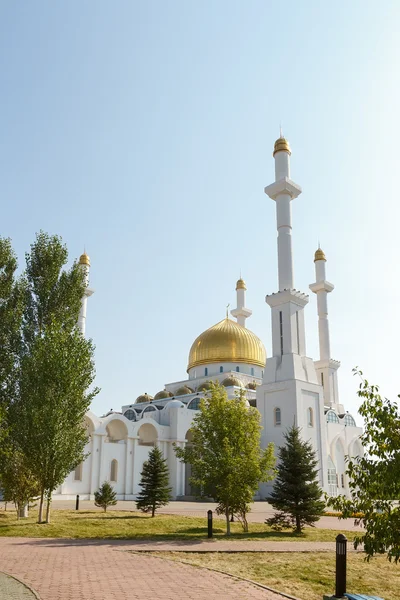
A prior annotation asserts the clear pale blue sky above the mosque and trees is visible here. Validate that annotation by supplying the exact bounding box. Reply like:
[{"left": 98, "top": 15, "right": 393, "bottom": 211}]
[{"left": 0, "top": 0, "right": 400, "bottom": 422}]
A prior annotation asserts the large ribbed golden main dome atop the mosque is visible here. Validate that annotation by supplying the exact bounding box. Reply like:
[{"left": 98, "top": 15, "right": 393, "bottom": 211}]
[{"left": 187, "top": 318, "right": 267, "bottom": 371}]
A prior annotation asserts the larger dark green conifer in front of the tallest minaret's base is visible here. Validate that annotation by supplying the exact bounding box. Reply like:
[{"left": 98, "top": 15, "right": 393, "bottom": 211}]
[{"left": 266, "top": 426, "right": 325, "bottom": 533}]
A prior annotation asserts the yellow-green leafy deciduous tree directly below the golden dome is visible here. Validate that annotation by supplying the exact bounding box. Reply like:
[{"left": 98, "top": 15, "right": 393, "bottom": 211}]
[{"left": 175, "top": 382, "right": 275, "bottom": 535}]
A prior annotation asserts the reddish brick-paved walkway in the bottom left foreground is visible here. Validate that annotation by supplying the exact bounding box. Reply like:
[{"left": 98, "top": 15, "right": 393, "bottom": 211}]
[{"left": 0, "top": 538, "right": 290, "bottom": 600}]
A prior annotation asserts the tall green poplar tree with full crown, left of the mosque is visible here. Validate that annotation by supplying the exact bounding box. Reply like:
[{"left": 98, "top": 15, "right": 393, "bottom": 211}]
[{"left": 9, "top": 232, "right": 98, "bottom": 523}]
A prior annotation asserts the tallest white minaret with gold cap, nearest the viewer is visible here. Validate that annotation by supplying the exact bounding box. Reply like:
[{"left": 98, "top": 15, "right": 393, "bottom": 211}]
[{"left": 256, "top": 135, "right": 327, "bottom": 497}]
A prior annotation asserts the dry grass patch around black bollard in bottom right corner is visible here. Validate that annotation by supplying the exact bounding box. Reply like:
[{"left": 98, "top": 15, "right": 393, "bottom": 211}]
[{"left": 152, "top": 552, "right": 400, "bottom": 600}]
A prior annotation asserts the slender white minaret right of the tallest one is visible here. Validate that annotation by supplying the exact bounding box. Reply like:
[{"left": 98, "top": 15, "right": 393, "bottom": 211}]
[{"left": 310, "top": 248, "right": 344, "bottom": 413}]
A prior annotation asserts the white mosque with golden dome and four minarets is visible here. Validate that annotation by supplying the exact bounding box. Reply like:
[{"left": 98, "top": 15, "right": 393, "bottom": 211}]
[{"left": 54, "top": 135, "right": 362, "bottom": 500}]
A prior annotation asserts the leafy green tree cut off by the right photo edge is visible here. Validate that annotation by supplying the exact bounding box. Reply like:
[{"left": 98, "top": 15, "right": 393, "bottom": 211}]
[{"left": 328, "top": 369, "right": 400, "bottom": 562}]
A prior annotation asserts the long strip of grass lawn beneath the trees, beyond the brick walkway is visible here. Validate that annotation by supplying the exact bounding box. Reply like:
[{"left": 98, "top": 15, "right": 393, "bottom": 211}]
[{"left": 0, "top": 510, "right": 351, "bottom": 542}]
